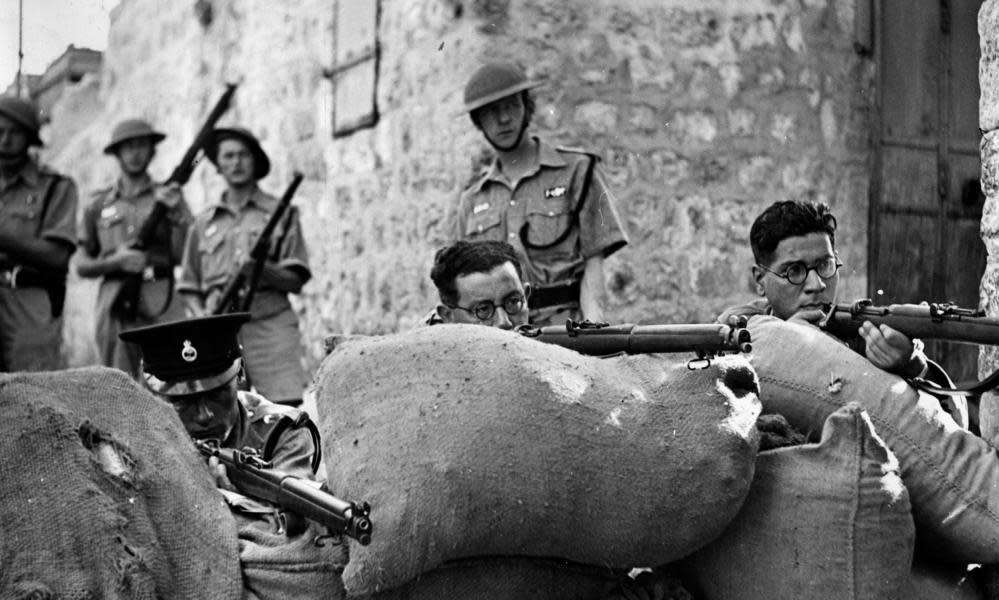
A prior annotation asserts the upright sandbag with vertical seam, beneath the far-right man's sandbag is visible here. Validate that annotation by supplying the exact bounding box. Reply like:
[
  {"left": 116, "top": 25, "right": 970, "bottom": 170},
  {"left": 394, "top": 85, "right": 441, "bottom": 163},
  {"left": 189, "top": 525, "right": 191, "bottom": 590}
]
[{"left": 685, "top": 404, "right": 915, "bottom": 600}]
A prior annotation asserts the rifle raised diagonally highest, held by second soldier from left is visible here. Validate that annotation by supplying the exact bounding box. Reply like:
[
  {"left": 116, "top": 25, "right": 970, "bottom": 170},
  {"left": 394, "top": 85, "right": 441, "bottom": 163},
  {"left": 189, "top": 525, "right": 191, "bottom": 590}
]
[{"left": 111, "top": 83, "right": 237, "bottom": 320}]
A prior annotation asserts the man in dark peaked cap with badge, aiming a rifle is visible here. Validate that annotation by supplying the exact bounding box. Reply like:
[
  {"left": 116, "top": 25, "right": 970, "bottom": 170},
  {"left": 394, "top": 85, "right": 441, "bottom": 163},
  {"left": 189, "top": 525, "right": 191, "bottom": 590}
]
[{"left": 121, "top": 313, "right": 347, "bottom": 600}]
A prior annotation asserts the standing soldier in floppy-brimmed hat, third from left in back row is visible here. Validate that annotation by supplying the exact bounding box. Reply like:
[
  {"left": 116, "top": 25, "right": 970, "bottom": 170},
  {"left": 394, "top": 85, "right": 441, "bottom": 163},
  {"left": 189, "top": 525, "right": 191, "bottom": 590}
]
[{"left": 177, "top": 128, "right": 312, "bottom": 406}]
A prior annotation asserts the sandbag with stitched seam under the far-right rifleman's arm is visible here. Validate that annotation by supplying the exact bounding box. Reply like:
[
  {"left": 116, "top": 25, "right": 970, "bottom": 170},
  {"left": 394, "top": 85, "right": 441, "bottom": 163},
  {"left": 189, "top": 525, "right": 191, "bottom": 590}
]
[{"left": 749, "top": 317, "right": 999, "bottom": 563}]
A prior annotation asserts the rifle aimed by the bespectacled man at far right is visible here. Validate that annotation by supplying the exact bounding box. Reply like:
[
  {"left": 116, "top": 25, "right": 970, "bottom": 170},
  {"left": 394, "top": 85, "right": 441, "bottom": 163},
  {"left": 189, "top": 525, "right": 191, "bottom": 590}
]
[{"left": 818, "top": 298, "right": 999, "bottom": 395}]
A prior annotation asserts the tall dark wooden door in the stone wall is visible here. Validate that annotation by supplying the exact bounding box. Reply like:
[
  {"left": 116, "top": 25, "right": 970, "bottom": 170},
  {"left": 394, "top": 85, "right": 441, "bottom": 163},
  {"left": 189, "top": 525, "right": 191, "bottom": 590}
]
[{"left": 869, "top": 0, "right": 986, "bottom": 382}]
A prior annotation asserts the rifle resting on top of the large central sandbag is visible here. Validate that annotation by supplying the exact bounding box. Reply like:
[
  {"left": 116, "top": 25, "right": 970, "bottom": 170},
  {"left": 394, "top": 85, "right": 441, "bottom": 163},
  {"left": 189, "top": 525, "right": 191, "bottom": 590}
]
[{"left": 517, "top": 317, "right": 753, "bottom": 368}]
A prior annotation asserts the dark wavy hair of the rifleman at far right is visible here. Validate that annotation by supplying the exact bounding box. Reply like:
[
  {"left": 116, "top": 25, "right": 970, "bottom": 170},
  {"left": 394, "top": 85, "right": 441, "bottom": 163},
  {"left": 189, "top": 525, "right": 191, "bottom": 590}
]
[{"left": 749, "top": 200, "right": 836, "bottom": 265}]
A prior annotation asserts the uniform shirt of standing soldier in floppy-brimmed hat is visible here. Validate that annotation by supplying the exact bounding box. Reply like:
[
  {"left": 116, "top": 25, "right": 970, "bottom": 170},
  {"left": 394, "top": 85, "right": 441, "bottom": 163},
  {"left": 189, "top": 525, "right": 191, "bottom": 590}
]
[{"left": 177, "top": 188, "right": 311, "bottom": 319}]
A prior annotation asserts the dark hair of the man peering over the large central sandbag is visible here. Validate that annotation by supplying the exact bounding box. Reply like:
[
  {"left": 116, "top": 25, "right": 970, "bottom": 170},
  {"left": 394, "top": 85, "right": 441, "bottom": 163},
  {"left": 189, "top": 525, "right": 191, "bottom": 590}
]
[{"left": 430, "top": 240, "right": 523, "bottom": 306}]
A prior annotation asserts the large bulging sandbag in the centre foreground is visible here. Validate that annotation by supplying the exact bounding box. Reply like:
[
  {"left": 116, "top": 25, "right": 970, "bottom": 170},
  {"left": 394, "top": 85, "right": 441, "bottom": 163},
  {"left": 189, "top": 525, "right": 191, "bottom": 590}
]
[{"left": 316, "top": 325, "right": 759, "bottom": 595}]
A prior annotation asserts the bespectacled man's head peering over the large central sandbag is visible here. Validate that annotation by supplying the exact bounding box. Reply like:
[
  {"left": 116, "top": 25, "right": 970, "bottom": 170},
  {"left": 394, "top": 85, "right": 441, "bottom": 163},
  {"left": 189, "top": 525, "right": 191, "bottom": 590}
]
[{"left": 427, "top": 241, "right": 530, "bottom": 329}]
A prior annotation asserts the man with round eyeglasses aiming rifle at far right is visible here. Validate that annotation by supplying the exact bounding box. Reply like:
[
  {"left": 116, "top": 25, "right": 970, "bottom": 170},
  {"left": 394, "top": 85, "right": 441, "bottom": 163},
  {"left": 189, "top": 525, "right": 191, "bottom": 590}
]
[{"left": 719, "top": 201, "right": 928, "bottom": 377}]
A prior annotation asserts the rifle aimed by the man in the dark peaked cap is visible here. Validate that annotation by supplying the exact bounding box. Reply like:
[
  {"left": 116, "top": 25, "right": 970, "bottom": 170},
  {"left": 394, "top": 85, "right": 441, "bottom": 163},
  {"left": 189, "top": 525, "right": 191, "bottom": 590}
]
[{"left": 194, "top": 440, "right": 372, "bottom": 546}]
